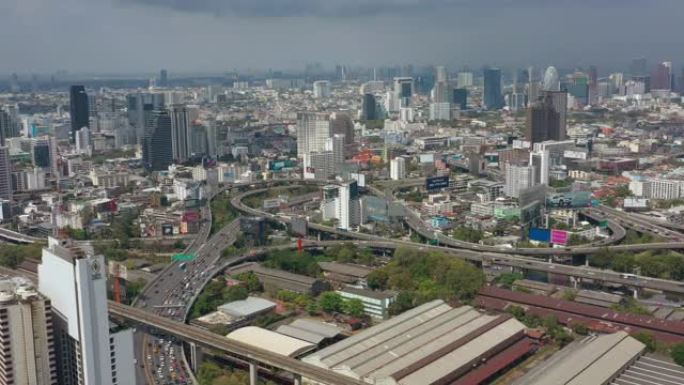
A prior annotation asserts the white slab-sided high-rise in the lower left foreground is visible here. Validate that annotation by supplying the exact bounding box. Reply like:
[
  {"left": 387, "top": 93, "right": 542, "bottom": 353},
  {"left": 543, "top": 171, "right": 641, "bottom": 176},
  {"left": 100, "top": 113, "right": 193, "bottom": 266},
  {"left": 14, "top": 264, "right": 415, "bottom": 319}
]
[{"left": 38, "top": 238, "right": 136, "bottom": 385}]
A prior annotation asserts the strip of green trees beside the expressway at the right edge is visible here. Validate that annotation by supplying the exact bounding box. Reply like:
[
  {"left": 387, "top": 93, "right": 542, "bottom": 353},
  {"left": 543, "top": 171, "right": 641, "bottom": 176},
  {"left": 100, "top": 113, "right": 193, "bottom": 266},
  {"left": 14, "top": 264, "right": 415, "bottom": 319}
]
[{"left": 589, "top": 249, "right": 684, "bottom": 281}]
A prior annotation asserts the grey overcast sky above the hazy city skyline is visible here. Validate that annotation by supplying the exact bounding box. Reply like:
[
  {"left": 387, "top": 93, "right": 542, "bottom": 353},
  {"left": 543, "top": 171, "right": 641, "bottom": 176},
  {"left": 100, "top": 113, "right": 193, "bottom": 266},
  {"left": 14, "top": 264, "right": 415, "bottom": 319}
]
[{"left": 0, "top": 0, "right": 684, "bottom": 74}]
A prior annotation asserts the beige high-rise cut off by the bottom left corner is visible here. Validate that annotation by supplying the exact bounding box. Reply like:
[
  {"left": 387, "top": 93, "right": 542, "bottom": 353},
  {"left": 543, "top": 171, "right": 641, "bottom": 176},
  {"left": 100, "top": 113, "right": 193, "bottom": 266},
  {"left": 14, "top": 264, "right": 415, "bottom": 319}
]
[{"left": 0, "top": 278, "right": 58, "bottom": 385}]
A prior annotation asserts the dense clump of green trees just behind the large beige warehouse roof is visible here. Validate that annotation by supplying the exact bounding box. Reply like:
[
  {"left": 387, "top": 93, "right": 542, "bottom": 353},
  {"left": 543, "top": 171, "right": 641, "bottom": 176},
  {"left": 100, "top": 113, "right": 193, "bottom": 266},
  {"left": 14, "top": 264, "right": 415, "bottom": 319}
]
[{"left": 368, "top": 248, "right": 485, "bottom": 314}]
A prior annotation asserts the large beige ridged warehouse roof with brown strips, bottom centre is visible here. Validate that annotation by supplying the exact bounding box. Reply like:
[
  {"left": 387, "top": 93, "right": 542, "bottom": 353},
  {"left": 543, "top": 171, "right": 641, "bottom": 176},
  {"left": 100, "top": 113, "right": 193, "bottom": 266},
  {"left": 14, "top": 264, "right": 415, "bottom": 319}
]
[{"left": 303, "top": 300, "right": 525, "bottom": 385}]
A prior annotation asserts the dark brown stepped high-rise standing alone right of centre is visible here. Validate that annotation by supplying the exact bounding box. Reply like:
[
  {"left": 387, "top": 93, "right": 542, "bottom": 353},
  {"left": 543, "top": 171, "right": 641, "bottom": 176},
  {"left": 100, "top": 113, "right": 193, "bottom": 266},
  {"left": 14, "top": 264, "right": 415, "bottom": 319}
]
[{"left": 525, "top": 91, "right": 566, "bottom": 143}]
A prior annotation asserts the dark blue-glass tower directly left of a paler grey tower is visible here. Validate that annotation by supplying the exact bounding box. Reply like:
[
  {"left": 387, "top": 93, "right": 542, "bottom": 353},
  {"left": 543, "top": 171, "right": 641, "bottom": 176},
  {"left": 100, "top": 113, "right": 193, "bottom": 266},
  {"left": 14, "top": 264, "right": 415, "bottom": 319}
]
[{"left": 143, "top": 110, "right": 173, "bottom": 171}]
